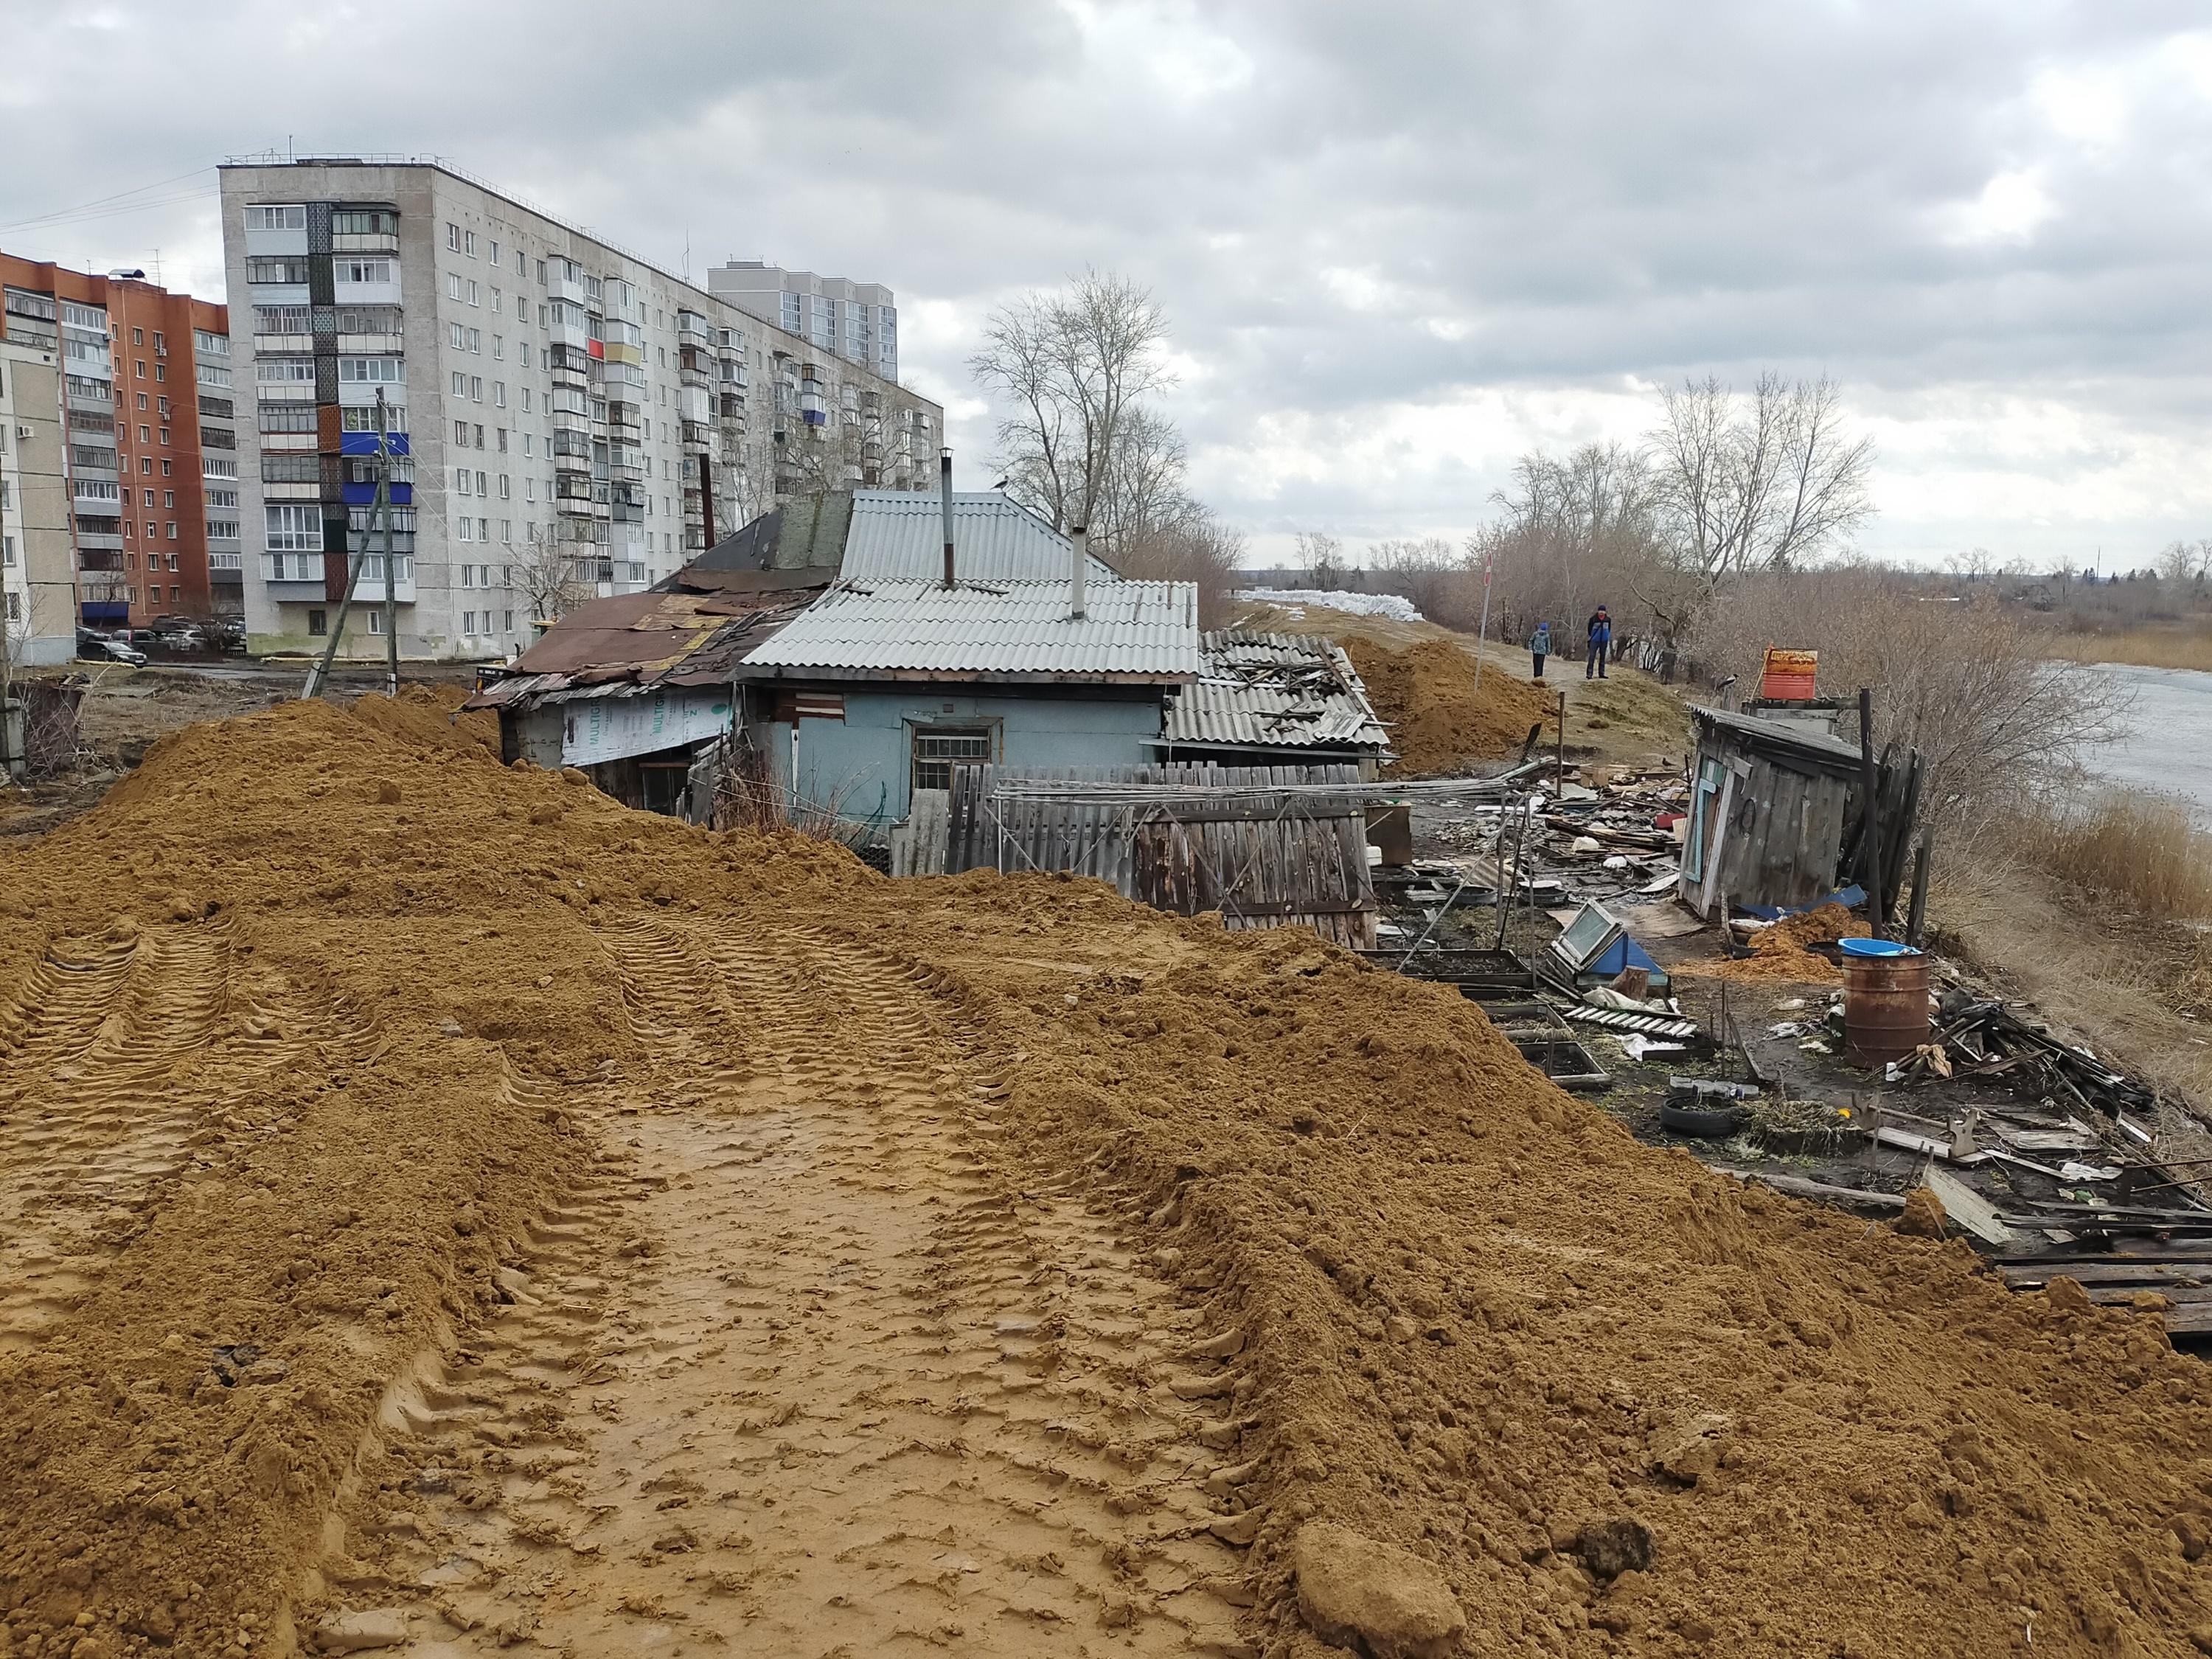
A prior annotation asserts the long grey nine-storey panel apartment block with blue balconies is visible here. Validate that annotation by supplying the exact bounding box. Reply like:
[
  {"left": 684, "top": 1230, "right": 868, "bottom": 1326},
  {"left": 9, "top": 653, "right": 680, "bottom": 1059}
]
[{"left": 221, "top": 157, "right": 942, "bottom": 659}]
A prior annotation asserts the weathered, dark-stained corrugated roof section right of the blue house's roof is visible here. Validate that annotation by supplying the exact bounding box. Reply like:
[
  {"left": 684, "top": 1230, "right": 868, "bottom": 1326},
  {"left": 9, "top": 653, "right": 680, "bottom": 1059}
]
[{"left": 1166, "top": 628, "right": 1389, "bottom": 754}]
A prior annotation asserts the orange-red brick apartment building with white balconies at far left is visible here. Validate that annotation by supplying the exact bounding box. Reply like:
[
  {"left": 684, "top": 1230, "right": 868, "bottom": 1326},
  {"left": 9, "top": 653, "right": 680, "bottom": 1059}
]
[{"left": 0, "top": 252, "right": 243, "bottom": 628}]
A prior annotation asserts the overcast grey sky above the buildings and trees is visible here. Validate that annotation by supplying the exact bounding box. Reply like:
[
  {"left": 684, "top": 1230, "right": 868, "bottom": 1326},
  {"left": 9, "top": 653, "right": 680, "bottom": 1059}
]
[{"left": 0, "top": 0, "right": 2212, "bottom": 568}]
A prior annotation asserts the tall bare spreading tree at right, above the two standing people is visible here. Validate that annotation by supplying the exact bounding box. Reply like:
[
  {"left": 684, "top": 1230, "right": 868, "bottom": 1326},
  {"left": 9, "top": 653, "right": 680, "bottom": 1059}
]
[{"left": 1646, "top": 372, "right": 1874, "bottom": 593}]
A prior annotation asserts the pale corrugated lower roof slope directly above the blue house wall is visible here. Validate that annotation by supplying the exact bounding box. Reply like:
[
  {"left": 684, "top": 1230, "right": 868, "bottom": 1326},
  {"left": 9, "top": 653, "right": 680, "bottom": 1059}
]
[{"left": 739, "top": 582, "right": 1199, "bottom": 684}]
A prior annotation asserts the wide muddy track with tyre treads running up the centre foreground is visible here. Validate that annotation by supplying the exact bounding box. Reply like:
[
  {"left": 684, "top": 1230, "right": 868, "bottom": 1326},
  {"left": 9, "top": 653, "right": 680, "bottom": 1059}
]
[{"left": 334, "top": 920, "right": 1245, "bottom": 1655}]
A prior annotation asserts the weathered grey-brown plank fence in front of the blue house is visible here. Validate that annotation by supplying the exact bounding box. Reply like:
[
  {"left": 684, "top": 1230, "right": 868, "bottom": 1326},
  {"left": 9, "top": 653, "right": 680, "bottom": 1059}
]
[{"left": 942, "top": 763, "right": 1376, "bottom": 949}]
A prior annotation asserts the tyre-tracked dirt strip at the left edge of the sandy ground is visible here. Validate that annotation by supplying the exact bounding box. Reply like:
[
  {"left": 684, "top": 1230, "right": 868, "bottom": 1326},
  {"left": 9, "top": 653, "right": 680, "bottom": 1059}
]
[{"left": 0, "top": 922, "right": 365, "bottom": 1349}]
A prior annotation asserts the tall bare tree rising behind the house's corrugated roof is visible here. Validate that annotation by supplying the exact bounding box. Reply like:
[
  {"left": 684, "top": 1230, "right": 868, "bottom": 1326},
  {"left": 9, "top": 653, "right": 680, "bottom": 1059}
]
[{"left": 969, "top": 270, "right": 1181, "bottom": 549}]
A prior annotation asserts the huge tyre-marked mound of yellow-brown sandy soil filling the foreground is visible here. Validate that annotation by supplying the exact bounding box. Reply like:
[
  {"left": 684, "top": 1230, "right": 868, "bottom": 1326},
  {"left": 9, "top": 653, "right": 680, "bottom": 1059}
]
[{"left": 0, "top": 695, "right": 2212, "bottom": 1659}]
